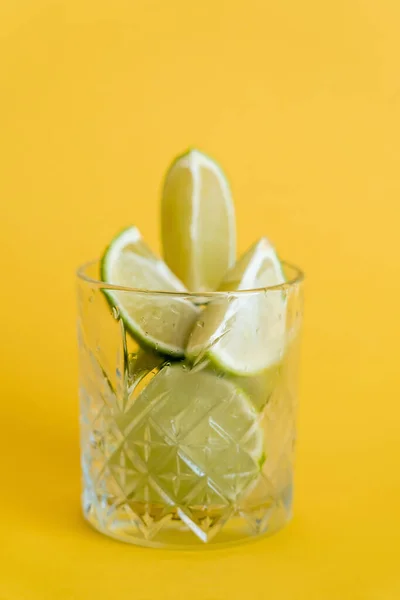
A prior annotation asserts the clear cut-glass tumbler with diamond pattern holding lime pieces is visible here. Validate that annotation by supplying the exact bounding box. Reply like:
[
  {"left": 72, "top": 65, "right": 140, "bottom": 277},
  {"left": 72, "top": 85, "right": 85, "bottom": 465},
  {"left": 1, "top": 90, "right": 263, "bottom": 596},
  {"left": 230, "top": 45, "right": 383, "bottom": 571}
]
[{"left": 78, "top": 262, "right": 303, "bottom": 548}]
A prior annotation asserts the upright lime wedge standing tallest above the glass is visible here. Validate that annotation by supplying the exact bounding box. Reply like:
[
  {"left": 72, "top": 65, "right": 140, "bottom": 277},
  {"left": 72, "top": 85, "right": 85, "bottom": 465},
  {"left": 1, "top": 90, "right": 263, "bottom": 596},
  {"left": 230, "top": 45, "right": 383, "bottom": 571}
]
[{"left": 161, "top": 150, "right": 236, "bottom": 292}]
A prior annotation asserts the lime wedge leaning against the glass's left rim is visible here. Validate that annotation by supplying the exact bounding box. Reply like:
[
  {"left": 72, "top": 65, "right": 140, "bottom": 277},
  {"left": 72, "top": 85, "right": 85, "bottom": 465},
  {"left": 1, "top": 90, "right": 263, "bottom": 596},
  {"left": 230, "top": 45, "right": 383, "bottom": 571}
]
[{"left": 101, "top": 227, "right": 198, "bottom": 356}]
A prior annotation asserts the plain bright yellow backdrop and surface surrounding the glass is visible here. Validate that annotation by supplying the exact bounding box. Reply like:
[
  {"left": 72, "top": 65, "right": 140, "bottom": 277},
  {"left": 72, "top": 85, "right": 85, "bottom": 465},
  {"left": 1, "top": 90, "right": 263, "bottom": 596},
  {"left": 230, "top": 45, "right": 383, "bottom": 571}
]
[{"left": 0, "top": 0, "right": 400, "bottom": 600}]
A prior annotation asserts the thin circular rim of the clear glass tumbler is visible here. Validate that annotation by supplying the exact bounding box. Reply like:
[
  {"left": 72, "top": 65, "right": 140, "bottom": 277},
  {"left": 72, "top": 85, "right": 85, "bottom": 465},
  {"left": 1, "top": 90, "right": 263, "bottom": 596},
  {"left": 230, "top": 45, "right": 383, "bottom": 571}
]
[{"left": 76, "top": 259, "right": 304, "bottom": 298}]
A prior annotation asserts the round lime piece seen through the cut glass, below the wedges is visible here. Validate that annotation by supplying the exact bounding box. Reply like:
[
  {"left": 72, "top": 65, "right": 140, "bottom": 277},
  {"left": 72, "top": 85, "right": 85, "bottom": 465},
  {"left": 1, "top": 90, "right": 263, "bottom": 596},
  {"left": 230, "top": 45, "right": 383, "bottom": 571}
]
[{"left": 113, "top": 363, "right": 264, "bottom": 506}]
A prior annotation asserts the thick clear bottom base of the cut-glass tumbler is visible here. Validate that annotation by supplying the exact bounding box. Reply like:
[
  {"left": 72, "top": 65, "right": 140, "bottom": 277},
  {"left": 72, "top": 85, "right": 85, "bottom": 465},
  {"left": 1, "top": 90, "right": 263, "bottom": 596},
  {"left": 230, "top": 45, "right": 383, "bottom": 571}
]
[{"left": 83, "top": 492, "right": 291, "bottom": 550}]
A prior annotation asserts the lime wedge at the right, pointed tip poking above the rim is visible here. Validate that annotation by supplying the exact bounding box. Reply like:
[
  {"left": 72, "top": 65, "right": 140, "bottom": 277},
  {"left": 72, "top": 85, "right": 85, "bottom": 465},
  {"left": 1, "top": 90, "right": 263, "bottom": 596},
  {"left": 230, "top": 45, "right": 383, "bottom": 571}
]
[{"left": 186, "top": 238, "right": 286, "bottom": 376}]
